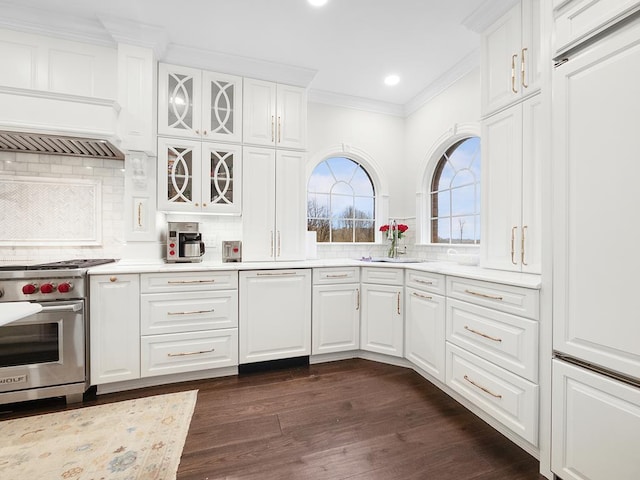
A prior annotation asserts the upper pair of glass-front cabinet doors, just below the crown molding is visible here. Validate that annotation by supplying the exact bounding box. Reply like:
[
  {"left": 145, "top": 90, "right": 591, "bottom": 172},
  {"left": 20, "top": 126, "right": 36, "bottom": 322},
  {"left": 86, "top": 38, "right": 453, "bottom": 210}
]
[{"left": 158, "top": 63, "right": 242, "bottom": 143}]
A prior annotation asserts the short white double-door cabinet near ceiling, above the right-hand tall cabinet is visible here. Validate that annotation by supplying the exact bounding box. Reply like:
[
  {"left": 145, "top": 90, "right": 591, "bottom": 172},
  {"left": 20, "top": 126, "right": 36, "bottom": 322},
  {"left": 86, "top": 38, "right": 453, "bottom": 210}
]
[{"left": 482, "top": 0, "right": 541, "bottom": 116}]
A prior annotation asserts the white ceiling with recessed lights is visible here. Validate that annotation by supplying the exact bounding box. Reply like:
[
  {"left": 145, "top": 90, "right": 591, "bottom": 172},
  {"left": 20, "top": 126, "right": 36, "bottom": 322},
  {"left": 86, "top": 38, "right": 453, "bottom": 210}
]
[{"left": 0, "top": 0, "right": 513, "bottom": 114}]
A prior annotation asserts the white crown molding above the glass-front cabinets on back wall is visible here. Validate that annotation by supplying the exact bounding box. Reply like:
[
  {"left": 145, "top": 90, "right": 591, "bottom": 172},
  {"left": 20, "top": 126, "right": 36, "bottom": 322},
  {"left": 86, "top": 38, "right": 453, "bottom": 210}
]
[{"left": 162, "top": 44, "right": 318, "bottom": 88}]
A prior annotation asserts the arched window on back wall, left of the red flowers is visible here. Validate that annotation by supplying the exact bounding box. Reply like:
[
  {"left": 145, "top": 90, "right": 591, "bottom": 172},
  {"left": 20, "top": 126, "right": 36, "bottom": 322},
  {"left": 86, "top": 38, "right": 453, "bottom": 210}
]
[{"left": 307, "top": 156, "right": 375, "bottom": 243}]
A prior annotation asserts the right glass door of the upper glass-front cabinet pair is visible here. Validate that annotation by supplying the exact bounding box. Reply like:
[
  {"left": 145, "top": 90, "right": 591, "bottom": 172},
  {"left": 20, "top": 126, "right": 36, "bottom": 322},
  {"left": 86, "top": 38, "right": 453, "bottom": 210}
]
[{"left": 202, "top": 72, "right": 242, "bottom": 143}]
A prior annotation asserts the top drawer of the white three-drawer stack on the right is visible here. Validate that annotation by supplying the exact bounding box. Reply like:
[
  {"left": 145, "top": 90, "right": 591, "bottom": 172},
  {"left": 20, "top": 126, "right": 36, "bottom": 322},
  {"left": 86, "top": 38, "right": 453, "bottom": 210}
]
[{"left": 447, "top": 277, "right": 540, "bottom": 320}]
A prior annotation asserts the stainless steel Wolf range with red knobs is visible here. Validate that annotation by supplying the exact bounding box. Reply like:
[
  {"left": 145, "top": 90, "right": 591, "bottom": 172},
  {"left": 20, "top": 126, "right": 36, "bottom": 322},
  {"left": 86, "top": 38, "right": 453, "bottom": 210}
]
[{"left": 0, "top": 259, "right": 114, "bottom": 404}]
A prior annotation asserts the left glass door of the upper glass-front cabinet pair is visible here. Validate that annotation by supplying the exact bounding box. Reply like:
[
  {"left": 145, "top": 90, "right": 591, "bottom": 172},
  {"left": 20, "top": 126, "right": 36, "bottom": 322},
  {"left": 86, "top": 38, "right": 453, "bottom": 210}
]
[{"left": 158, "top": 63, "right": 202, "bottom": 138}]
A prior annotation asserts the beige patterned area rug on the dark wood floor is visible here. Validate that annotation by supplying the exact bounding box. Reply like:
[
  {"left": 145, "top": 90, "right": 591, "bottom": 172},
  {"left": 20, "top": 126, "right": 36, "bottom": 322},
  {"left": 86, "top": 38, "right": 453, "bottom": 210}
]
[{"left": 0, "top": 390, "right": 198, "bottom": 480}]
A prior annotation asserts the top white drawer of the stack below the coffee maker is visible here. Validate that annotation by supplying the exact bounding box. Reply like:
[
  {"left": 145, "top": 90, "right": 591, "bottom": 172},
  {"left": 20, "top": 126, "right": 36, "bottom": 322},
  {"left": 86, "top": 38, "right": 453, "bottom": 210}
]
[{"left": 140, "top": 271, "right": 238, "bottom": 293}]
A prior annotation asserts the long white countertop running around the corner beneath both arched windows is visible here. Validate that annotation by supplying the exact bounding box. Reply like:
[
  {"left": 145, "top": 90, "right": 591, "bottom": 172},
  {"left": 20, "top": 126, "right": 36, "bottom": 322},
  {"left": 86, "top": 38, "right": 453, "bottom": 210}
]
[{"left": 89, "top": 258, "right": 542, "bottom": 289}]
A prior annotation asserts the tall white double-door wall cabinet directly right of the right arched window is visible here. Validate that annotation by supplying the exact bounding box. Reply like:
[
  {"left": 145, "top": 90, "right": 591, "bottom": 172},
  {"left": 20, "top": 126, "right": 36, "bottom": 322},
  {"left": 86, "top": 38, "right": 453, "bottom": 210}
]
[{"left": 480, "top": 89, "right": 545, "bottom": 273}]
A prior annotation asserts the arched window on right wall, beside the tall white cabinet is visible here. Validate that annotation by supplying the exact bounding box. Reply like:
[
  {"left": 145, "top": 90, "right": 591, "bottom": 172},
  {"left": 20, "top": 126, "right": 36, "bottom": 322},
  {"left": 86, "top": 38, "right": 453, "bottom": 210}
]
[{"left": 430, "top": 137, "right": 480, "bottom": 244}]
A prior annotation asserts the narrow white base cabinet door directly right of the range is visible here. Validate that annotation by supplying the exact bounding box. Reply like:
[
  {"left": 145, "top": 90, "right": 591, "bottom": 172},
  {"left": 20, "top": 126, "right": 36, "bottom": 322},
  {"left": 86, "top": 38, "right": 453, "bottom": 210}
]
[{"left": 89, "top": 274, "right": 140, "bottom": 385}]
